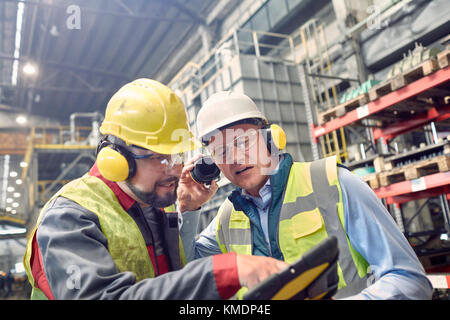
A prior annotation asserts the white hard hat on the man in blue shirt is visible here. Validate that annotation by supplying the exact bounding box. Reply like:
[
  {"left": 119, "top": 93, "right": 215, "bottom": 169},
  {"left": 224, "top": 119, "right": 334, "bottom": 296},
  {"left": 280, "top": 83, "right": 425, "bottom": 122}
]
[{"left": 197, "top": 91, "right": 268, "bottom": 140}]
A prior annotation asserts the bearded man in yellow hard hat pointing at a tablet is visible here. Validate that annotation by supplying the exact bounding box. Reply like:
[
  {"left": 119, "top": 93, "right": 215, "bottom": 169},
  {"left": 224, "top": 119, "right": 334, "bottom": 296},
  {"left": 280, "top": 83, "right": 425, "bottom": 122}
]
[{"left": 24, "top": 79, "right": 286, "bottom": 299}]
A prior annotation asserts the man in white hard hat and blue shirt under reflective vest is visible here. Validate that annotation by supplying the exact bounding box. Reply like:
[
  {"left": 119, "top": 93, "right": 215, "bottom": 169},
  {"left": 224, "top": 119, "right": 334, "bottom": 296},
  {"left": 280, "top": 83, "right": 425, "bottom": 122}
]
[{"left": 181, "top": 92, "right": 432, "bottom": 299}]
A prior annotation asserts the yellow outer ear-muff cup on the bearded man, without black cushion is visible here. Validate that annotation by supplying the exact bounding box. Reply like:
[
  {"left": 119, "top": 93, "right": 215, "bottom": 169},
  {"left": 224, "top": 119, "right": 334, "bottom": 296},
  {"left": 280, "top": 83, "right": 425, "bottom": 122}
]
[{"left": 97, "top": 147, "right": 130, "bottom": 182}]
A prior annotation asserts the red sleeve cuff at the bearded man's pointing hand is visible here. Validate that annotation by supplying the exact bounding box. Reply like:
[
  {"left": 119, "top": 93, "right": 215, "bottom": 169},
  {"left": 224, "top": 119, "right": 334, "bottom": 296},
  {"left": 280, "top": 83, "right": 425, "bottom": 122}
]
[{"left": 213, "top": 252, "right": 241, "bottom": 300}]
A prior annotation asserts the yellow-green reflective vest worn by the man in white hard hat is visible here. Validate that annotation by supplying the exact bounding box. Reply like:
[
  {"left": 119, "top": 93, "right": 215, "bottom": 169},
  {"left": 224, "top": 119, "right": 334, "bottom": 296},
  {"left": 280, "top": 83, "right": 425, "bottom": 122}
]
[{"left": 216, "top": 156, "right": 369, "bottom": 298}]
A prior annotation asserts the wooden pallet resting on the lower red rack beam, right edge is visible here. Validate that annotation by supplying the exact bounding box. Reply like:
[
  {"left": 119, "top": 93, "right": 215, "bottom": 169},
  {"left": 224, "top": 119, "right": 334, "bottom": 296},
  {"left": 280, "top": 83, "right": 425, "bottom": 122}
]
[{"left": 378, "top": 154, "right": 450, "bottom": 187}]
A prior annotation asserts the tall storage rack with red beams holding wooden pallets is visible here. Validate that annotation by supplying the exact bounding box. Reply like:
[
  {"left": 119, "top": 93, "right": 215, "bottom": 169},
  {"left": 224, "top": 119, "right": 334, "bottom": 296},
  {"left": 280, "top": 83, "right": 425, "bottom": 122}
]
[{"left": 311, "top": 48, "right": 450, "bottom": 280}]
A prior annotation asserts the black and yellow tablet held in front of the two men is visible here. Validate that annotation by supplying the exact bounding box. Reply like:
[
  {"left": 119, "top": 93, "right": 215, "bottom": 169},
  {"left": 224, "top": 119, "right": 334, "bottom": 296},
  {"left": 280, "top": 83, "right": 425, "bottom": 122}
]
[{"left": 243, "top": 236, "right": 339, "bottom": 300}]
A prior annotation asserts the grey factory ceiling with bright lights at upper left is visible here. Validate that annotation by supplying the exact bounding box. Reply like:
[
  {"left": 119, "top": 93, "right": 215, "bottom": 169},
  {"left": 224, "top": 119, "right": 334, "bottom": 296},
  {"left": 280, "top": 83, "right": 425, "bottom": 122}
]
[{"left": 0, "top": 0, "right": 217, "bottom": 121}]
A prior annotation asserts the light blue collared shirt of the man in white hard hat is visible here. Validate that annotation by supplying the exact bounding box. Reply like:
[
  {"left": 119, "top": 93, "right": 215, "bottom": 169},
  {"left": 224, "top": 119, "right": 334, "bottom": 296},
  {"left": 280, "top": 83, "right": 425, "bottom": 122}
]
[{"left": 181, "top": 162, "right": 433, "bottom": 300}]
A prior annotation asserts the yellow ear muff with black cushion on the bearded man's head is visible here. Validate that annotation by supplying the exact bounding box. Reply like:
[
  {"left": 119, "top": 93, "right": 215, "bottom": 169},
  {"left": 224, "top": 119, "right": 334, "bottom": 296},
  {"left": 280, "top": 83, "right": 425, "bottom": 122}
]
[{"left": 97, "top": 139, "right": 136, "bottom": 182}]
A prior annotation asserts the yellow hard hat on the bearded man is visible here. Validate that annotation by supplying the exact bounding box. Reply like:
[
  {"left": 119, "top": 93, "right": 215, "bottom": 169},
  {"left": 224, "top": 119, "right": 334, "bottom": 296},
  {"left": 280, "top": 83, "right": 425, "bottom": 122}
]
[{"left": 100, "top": 79, "right": 201, "bottom": 154}]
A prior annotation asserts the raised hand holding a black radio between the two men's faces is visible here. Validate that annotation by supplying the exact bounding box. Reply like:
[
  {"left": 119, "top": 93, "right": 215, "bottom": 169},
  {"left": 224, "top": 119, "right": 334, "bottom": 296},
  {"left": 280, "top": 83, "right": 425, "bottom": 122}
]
[{"left": 177, "top": 155, "right": 220, "bottom": 213}]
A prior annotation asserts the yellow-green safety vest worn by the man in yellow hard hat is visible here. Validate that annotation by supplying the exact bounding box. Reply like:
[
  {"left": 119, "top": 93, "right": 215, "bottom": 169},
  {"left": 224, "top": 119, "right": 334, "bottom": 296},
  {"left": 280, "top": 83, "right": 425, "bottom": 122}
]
[{"left": 24, "top": 174, "right": 187, "bottom": 299}]
